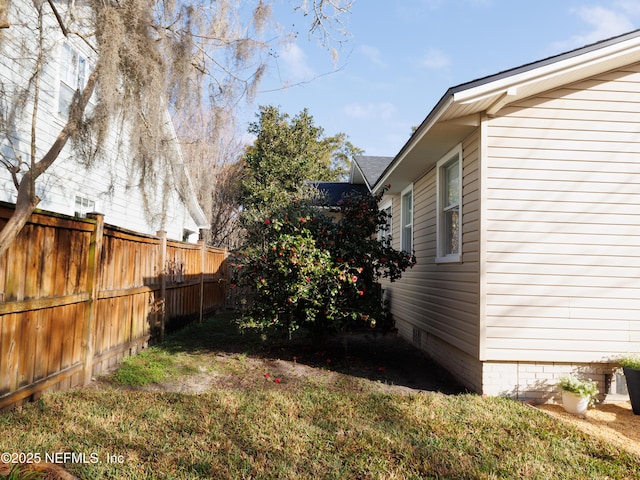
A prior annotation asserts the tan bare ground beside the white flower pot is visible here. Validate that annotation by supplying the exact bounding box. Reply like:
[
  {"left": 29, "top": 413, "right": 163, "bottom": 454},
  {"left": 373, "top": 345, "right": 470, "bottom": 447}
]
[{"left": 537, "top": 402, "right": 640, "bottom": 456}]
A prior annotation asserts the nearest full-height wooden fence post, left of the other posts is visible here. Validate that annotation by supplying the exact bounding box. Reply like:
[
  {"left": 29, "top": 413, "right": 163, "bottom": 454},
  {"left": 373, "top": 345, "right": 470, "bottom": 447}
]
[{"left": 82, "top": 213, "right": 104, "bottom": 385}]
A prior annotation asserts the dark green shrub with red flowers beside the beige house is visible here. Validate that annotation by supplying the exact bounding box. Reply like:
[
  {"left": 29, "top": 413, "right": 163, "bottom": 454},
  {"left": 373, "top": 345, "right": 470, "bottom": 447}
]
[{"left": 234, "top": 188, "right": 415, "bottom": 335}]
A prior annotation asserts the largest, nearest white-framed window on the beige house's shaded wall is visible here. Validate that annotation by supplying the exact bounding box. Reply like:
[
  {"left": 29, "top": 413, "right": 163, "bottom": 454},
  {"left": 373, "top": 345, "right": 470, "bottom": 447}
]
[{"left": 436, "top": 147, "right": 462, "bottom": 262}]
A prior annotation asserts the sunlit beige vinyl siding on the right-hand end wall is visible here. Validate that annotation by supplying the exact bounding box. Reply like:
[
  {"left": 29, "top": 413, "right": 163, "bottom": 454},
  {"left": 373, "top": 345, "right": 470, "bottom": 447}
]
[{"left": 484, "top": 66, "right": 640, "bottom": 362}]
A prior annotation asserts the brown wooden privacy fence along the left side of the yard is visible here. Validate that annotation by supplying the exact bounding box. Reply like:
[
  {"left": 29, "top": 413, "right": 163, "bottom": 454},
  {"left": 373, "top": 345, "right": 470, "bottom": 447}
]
[{"left": 0, "top": 204, "right": 227, "bottom": 411}]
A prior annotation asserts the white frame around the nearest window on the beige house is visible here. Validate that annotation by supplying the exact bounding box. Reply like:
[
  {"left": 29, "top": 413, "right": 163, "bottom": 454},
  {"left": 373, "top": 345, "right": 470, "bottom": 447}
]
[{"left": 435, "top": 145, "right": 462, "bottom": 263}]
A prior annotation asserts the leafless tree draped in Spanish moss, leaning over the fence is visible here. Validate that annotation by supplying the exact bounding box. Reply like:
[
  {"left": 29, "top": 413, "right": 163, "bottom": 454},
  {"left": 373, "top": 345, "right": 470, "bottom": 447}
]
[{"left": 0, "top": 0, "right": 351, "bottom": 255}]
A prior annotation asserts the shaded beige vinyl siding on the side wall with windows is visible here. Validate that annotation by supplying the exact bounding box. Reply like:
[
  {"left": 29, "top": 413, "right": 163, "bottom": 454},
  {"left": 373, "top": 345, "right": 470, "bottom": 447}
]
[{"left": 385, "top": 129, "right": 479, "bottom": 357}]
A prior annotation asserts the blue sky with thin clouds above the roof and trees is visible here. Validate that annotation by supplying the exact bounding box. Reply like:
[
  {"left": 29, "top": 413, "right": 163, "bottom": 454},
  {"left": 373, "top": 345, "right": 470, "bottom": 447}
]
[{"left": 247, "top": 0, "right": 640, "bottom": 156}]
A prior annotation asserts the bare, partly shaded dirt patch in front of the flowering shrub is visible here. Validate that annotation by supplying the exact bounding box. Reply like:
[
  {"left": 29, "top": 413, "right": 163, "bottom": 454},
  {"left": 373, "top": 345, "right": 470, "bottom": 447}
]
[{"left": 127, "top": 331, "right": 464, "bottom": 394}]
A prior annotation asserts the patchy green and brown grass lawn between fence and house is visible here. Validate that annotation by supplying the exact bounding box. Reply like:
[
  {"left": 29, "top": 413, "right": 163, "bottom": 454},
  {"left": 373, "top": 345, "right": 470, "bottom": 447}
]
[{"left": 0, "top": 317, "right": 640, "bottom": 479}]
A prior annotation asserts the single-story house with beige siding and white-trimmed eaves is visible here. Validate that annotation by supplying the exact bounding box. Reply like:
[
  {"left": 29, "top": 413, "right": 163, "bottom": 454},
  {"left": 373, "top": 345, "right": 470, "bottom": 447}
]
[{"left": 356, "top": 31, "right": 640, "bottom": 402}]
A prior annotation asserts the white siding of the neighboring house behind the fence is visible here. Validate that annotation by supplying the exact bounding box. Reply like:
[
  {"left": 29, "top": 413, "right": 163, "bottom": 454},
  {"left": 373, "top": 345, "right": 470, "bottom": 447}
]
[{"left": 0, "top": 0, "right": 198, "bottom": 241}]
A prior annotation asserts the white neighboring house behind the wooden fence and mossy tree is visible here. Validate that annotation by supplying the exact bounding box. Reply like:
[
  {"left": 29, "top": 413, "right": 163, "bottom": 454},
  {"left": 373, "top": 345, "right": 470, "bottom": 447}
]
[{"left": 0, "top": 0, "right": 208, "bottom": 241}]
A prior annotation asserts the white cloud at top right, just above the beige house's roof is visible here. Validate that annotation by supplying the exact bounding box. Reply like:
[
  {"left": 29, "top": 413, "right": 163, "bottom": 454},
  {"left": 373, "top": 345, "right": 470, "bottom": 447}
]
[{"left": 553, "top": 6, "right": 637, "bottom": 50}]
